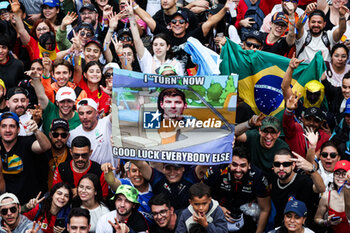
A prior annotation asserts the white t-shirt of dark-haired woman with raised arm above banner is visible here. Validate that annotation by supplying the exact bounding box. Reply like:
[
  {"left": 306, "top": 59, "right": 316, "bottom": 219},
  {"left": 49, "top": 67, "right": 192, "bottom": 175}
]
[{"left": 137, "top": 48, "right": 184, "bottom": 76}]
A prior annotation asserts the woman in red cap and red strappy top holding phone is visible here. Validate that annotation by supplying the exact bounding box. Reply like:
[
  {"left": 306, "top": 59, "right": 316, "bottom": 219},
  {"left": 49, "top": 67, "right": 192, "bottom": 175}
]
[{"left": 315, "top": 160, "right": 350, "bottom": 233}]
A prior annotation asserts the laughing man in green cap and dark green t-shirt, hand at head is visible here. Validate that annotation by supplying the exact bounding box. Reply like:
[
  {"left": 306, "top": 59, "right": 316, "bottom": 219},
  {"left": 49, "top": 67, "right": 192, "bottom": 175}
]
[{"left": 235, "top": 114, "right": 289, "bottom": 181}]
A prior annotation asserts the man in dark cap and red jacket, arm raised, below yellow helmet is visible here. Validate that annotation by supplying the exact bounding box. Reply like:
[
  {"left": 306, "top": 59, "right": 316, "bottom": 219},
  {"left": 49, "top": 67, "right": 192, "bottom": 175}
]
[{"left": 282, "top": 89, "right": 330, "bottom": 158}]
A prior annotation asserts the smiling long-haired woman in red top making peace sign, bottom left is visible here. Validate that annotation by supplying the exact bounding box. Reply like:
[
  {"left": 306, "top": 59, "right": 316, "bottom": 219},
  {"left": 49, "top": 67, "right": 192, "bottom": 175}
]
[{"left": 23, "top": 183, "right": 73, "bottom": 233}]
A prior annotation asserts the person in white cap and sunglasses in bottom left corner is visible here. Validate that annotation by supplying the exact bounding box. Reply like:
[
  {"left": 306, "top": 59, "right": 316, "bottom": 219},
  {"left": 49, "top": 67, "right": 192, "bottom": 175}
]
[{"left": 0, "top": 193, "right": 42, "bottom": 233}]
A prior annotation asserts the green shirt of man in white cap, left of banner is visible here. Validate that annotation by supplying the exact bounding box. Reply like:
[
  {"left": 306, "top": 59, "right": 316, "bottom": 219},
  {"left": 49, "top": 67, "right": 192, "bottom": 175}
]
[{"left": 43, "top": 101, "right": 81, "bottom": 136}]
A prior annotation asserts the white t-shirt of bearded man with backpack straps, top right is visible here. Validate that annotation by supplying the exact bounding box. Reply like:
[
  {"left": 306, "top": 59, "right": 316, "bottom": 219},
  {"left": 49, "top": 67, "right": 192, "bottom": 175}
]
[{"left": 295, "top": 28, "right": 336, "bottom": 62}]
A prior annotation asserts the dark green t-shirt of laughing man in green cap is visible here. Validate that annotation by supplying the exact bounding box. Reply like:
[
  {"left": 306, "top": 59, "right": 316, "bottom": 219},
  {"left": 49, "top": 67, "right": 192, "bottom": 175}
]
[{"left": 246, "top": 129, "right": 289, "bottom": 181}]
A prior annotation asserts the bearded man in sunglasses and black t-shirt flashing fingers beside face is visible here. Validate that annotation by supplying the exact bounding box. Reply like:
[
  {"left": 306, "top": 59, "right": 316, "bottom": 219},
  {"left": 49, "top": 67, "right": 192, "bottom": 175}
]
[{"left": 271, "top": 149, "right": 326, "bottom": 226}]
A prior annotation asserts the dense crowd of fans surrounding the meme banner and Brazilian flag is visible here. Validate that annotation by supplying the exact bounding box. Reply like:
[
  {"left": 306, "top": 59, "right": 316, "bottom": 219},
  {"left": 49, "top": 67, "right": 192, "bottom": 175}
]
[{"left": 0, "top": 0, "right": 350, "bottom": 233}]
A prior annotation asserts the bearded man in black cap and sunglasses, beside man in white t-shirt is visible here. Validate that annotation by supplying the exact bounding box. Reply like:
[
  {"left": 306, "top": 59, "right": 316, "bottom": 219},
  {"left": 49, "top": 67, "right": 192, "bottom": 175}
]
[{"left": 48, "top": 118, "right": 72, "bottom": 190}]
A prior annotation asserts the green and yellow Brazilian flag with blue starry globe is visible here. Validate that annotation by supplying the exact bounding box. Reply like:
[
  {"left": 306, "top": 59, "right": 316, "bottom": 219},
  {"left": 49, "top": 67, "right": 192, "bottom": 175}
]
[{"left": 220, "top": 39, "right": 326, "bottom": 115}]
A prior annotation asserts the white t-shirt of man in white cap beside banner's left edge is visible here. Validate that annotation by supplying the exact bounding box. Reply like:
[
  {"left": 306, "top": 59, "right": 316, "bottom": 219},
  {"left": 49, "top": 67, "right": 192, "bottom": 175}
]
[{"left": 67, "top": 115, "right": 113, "bottom": 167}]
